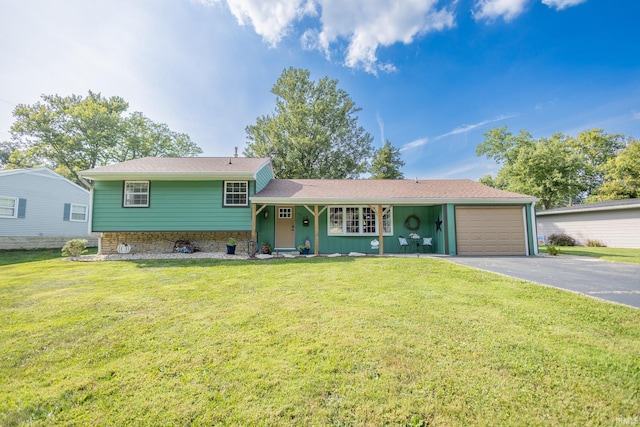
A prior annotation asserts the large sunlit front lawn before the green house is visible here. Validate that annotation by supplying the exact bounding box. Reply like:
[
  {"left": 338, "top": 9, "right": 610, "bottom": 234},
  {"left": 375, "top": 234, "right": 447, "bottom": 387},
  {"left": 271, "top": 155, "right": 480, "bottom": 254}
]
[{"left": 0, "top": 253, "right": 640, "bottom": 426}]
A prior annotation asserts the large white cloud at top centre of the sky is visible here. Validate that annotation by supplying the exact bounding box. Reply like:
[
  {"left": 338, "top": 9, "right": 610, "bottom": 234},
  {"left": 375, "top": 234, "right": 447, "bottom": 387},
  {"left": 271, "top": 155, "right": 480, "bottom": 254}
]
[{"left": 205, "top": 0, "right": 457, "bottom": 74}]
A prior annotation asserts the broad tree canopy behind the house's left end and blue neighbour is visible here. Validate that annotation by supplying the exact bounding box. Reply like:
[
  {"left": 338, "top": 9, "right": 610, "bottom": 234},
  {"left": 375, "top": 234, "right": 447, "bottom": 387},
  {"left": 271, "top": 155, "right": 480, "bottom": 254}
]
[{"left": 0, "top": 91, "right": 202, "bottom": 185}]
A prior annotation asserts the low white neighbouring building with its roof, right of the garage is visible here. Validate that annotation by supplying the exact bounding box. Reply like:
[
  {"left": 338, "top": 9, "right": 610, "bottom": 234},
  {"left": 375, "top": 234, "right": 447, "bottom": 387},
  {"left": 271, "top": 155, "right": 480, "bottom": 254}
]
[{"left": 536, "top": 199, "right": 640, "bottom": 248}]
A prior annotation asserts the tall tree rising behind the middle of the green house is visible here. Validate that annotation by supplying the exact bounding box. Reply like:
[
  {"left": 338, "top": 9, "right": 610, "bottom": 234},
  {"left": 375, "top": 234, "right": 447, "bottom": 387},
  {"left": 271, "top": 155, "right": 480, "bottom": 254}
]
[{"left": 243, "top": 68, "right": 373, "bottom": 179}]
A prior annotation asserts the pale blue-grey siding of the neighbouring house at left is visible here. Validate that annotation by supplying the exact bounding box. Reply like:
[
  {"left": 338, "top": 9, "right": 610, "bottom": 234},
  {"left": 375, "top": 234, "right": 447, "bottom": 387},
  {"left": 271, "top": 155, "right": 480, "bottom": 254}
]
[{"left": 0, "top": 168, "right": 90, "bottom": 238}]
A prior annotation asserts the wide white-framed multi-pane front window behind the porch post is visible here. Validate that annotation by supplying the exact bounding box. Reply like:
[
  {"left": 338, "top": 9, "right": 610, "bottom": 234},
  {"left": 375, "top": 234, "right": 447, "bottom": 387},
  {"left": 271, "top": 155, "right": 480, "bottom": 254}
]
[{"left": 327, "top": 206, "right": 393, "bottom": 236}]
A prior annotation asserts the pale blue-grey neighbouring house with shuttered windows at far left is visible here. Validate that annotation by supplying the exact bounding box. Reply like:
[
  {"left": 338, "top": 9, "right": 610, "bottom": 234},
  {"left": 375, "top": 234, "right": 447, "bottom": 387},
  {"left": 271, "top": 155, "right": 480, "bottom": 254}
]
[{"left": 0, "top": 168, "right": 96, "bottom": 249}]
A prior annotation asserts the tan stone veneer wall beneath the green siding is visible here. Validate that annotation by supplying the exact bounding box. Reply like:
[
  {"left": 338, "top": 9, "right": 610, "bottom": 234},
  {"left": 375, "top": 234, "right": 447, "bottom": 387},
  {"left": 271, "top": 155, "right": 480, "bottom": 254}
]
[{"left": 100, "top": 231, "right": 251, "bottom": 255}]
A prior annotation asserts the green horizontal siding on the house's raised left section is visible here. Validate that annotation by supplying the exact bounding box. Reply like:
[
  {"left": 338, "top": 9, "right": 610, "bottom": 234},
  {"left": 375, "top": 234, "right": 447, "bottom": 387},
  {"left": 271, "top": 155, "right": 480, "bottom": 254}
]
[{"left": 92, "top": 181, "right": 252, "bottom": 232}]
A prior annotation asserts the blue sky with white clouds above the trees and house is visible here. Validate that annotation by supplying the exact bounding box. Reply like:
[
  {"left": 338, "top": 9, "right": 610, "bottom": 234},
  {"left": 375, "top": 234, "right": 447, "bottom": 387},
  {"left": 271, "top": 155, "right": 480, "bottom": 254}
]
[{"left": 0, "top": 0, "right": 640, "bottom": 180}]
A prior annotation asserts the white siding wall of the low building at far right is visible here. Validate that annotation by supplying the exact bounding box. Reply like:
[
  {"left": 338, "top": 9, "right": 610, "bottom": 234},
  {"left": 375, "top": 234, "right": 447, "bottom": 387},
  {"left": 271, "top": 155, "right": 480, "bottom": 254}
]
[{"left": 537, "top": 208, "right": 640, "bottom": 248}]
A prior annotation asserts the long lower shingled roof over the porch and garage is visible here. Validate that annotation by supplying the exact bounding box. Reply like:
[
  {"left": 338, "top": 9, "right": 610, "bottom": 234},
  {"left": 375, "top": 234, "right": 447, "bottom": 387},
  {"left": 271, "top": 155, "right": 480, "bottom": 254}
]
[{"left": 251, "top": 179, "right": 537, "bottom": 205}]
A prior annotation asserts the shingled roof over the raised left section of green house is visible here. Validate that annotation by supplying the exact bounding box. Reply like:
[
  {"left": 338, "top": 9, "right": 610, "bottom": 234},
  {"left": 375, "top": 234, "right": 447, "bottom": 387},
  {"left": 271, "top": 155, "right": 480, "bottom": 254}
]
[{"left": 80, "top": 156, "right": 271, "bottom": 180}]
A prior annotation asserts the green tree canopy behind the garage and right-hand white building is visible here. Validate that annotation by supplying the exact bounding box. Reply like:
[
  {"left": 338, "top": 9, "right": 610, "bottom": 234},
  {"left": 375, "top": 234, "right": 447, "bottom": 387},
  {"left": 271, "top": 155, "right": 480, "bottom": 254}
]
[{"left": 476, "top": 126, "right": 637, "bottom": 209}]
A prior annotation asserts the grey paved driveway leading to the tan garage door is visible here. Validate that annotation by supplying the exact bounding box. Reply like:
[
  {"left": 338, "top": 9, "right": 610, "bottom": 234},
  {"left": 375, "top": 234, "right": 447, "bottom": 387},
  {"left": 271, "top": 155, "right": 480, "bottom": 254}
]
[{"left": 446, "top": 255, "right": 640, "bottom": 308}]
